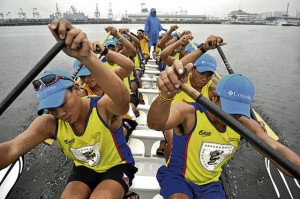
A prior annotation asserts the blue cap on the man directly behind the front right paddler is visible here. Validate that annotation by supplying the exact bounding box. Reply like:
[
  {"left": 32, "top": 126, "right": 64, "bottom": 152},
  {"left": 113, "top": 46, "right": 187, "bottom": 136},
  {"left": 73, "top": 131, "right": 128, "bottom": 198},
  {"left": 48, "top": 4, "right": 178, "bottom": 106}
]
[{"left": 194, "top": 54, "right": 217, "bottom": 73}]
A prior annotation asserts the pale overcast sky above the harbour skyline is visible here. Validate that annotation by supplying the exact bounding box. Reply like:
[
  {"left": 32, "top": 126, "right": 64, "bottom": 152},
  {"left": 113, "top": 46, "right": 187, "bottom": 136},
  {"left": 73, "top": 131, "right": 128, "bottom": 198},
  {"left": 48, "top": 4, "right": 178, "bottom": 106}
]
[{"left": 0, "top": 0, "right": 300, "bottom": 18}]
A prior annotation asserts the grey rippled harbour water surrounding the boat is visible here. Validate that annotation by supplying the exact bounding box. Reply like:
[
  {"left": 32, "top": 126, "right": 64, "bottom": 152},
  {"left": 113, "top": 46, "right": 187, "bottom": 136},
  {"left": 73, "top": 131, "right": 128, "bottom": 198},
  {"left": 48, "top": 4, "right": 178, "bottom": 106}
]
[{"left": 0, "top": 24, "right": 300, "bottom": 198}]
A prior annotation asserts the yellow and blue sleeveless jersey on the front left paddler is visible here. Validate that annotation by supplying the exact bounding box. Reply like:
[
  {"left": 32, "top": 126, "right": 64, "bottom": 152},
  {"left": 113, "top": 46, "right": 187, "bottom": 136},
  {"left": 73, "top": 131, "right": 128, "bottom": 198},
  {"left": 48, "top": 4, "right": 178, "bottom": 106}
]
[{"left": 56, "top": 97, "right": 134, "bottom": 173}]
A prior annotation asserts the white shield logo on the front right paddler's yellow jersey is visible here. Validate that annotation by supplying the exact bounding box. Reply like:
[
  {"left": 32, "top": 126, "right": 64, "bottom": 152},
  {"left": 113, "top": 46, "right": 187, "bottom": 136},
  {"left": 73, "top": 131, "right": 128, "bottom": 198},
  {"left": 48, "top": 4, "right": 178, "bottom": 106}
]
[{"left": 199, "top": 142, "right": 234, "bottom": 171}]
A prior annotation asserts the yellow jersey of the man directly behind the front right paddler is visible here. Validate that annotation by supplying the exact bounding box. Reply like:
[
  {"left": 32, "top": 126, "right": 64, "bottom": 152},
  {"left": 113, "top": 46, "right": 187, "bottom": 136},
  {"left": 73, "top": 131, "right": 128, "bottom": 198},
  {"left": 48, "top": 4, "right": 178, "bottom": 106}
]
[{"left": 172, "top": 73, "right": 212, "bottom": 104}]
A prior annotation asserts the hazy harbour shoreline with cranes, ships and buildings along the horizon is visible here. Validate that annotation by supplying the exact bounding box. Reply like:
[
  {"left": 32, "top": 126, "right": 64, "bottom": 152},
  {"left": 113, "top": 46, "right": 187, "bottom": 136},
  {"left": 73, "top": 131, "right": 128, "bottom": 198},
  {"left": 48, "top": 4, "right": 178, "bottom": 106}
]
[{"left": 0, "top": 2, "right": 300, "bottom": 26}]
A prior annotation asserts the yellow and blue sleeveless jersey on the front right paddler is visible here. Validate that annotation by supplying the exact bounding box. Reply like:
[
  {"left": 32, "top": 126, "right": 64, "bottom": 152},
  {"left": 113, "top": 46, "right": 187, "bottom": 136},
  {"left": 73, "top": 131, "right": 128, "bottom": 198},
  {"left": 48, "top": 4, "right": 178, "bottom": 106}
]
[{"left": 167, "top": 102, "right": 240, "bottom": 185}]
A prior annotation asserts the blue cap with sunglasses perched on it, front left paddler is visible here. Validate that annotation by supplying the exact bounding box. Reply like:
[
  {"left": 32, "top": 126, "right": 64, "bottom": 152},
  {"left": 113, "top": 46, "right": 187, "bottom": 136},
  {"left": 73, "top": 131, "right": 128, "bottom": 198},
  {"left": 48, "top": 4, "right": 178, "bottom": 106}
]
[{"left": 36, "top": 69, "right": 74, "bottom": 115}]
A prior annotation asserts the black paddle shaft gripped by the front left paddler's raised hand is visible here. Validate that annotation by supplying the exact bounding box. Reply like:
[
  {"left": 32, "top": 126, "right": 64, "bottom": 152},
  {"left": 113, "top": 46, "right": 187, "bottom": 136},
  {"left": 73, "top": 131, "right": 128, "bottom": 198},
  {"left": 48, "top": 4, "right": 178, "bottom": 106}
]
[{"left": 0, "top": 40, "right": 65, "bottom": 116}]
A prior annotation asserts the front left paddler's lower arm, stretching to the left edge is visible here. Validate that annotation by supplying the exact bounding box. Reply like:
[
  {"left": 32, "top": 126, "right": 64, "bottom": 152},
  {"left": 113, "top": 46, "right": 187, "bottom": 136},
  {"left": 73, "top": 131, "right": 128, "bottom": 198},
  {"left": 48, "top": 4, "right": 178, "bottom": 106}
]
[{"left": 0, "top": 115, "right": 56, "bottom": 169}]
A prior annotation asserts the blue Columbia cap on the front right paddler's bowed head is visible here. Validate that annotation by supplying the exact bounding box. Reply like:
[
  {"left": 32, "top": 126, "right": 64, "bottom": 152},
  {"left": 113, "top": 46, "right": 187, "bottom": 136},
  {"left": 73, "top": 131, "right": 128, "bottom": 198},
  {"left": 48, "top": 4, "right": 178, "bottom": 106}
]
[{"left": 216, "top": 74, "right": 254, "bottom": 118}]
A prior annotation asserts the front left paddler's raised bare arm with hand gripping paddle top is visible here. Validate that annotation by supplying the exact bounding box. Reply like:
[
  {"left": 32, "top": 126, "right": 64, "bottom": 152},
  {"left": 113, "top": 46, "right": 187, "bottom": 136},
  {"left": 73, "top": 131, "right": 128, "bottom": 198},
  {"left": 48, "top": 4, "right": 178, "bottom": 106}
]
[{"left": 49, "top": 20, "right": 130, "bottom": 115}]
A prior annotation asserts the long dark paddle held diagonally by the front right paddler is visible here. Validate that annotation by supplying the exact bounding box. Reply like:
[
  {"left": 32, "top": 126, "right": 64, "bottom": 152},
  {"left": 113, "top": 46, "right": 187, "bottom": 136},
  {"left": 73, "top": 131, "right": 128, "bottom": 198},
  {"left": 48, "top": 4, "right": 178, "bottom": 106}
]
[{"left": 181, "top": 83, "right": 300, "bottom": 179}]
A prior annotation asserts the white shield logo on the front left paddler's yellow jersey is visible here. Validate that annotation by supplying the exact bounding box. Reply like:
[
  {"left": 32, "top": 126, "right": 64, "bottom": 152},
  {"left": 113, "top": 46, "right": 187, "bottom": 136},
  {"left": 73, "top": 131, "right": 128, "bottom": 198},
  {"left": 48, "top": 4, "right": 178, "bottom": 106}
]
[{"left": 70, "top": 142, "right": 100, "bottom": 167}]
